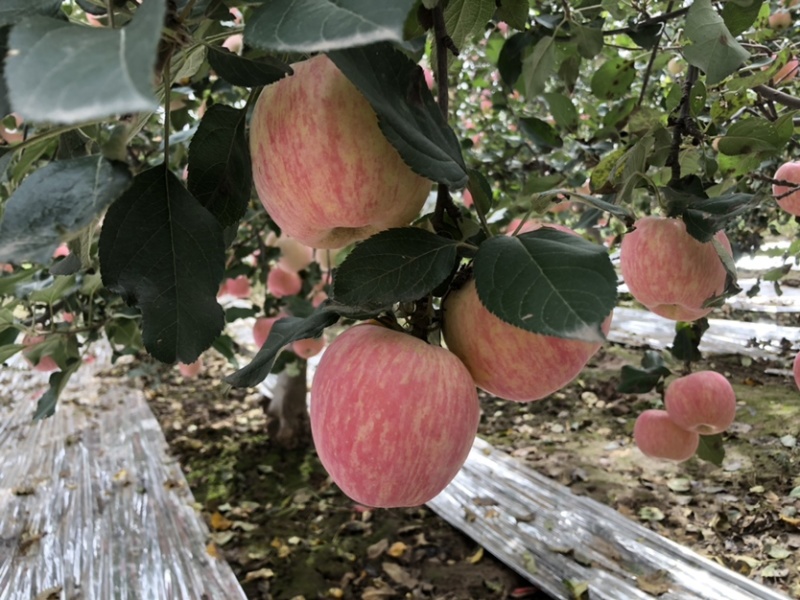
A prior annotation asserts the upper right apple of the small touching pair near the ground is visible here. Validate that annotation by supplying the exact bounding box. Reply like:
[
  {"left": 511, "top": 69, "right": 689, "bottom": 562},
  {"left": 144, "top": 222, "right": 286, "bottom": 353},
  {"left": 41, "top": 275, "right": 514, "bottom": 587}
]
[{"left": 664, "top": 371, "right": 736, "bottom": 435}]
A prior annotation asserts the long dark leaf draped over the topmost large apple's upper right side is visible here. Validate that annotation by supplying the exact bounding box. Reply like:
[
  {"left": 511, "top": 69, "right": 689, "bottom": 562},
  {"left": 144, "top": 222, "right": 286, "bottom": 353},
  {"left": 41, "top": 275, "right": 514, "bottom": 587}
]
[{"left": 329, "top": 44, "right": 467, "bottom": 189}]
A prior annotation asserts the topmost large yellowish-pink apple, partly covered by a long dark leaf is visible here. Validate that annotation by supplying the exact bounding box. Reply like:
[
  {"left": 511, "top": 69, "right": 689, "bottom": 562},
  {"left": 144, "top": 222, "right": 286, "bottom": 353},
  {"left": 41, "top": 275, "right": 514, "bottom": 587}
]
[{"left": 250, "top": 55, "right": 431, "bottom": 248}]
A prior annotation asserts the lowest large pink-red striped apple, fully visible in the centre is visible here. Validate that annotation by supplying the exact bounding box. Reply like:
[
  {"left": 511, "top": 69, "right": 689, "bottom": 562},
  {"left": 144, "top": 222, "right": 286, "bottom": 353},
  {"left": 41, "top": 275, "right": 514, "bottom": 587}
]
[{"left": 310, "top": 323, "right": 480, "bottom": 508}]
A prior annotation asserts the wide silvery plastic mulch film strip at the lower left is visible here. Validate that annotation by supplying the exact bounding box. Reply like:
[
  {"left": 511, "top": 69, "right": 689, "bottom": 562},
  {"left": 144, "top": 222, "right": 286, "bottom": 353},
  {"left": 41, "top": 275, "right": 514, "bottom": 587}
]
[{"left": 0, "top": 345, "right": 245, "bottom": 600}]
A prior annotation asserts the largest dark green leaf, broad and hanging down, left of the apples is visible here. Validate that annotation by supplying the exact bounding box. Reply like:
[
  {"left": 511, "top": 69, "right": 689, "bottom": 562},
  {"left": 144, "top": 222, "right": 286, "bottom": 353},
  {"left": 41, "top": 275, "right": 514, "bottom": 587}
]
[{"left": 100, "top": 164, "right": 225, "bottom": 363}]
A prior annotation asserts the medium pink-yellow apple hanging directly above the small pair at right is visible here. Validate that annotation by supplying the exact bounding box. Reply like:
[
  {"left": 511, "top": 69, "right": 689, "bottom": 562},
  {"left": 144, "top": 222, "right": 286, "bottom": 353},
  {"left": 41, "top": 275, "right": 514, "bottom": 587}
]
[{"left": 620, "top": 217, "right": 731, "bottom": 321}]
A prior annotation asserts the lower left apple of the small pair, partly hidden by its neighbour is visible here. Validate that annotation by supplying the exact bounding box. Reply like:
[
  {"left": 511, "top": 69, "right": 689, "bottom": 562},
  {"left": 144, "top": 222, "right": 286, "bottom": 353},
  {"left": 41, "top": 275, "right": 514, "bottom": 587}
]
[{"left": 633, "top": 409, "right": 700, "bottom": 462}]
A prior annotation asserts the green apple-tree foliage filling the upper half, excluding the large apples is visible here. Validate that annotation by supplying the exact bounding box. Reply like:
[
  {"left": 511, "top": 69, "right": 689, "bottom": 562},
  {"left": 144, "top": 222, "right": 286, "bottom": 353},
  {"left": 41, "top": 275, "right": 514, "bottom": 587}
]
[{"left": 0, "top": 0, "right": 800, "bottom": 450}]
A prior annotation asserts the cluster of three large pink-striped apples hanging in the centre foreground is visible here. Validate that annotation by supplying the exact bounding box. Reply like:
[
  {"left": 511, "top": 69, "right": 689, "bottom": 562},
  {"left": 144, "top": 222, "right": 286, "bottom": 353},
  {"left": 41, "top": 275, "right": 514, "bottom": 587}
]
[{"left": 250, "top": 56, "right": 599, "bottom": 507}]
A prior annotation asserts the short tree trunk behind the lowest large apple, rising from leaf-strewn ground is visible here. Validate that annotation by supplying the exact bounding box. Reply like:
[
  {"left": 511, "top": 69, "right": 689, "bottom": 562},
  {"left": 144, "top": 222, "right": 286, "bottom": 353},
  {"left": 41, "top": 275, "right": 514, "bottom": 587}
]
[{"left": 262, "top": 360, "right": 311, "bottom": 448}]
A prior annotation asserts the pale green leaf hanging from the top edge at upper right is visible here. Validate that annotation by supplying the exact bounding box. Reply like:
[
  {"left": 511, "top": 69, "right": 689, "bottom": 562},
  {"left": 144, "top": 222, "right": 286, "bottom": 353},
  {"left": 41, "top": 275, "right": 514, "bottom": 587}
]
[{"left": 683, "top": 0, "right": 750, "bottom": 85}]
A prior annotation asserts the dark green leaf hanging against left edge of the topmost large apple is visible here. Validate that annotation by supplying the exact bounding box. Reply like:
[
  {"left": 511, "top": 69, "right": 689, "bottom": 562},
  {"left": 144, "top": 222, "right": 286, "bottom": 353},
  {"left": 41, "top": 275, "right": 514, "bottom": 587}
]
[{"left": 187, "top": 104, "right": 253, "bottom": 227}]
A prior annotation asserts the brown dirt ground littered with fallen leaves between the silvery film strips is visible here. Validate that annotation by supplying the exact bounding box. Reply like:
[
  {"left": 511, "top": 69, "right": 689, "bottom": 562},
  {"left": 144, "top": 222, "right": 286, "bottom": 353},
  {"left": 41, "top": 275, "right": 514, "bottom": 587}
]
[{"left": 145, "top": 328, "right": 800, "bottom": 600}]
